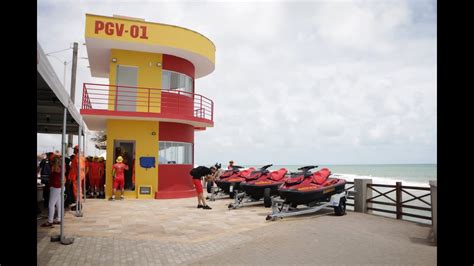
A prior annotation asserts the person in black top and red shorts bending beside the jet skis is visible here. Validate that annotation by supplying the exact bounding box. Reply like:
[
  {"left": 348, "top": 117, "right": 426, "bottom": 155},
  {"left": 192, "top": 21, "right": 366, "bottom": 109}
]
[{"left": 189, "top": 160, "right": 234, "bottom": 210}]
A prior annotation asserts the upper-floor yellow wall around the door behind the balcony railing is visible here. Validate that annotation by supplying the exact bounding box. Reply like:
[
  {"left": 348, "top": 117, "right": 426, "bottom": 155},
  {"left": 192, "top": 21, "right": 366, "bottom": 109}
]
[{"left": 109, "top": 49, "right": 163, "bottom": 113}]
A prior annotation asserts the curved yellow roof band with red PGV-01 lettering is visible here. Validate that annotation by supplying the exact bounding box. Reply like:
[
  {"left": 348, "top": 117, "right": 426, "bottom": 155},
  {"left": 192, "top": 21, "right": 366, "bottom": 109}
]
[{"left": 86, "top": 14, "right": 216, "bottom": 64}]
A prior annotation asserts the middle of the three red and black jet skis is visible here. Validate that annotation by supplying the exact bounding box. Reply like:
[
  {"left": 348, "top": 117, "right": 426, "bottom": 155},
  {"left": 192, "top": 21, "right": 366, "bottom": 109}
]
[{"left": 240, "top": 164, "right": 288, "bottom": 207}]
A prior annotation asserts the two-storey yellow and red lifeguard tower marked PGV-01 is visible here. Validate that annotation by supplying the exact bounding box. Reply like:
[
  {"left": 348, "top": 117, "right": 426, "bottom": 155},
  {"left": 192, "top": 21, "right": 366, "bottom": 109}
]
[{"left": 80, "top": 14, "right": 215, "bottom": 199}]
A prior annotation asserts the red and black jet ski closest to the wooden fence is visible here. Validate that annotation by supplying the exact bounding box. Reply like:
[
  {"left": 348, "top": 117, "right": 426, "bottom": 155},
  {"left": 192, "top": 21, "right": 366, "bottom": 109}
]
[{"left": 278, "top": 166, "right": 346, "bottom": 208}]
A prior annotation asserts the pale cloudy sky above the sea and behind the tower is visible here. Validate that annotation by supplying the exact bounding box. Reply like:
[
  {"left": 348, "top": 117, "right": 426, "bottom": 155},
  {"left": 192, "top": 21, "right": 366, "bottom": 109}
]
[{"left": 37, "top": 0, "right": 437, "bottom": 165}]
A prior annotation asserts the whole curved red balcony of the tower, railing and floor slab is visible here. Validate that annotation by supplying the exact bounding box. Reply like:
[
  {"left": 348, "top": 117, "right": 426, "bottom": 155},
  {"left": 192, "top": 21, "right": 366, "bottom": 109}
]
[{"left": 81, "top": 83, "right": 214, "bottom": 130}]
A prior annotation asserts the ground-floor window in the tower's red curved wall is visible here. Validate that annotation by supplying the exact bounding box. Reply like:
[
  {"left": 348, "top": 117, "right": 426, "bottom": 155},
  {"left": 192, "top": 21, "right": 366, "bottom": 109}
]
[{"left": 158, "top": 141, "right": 193, "bottom": 164}]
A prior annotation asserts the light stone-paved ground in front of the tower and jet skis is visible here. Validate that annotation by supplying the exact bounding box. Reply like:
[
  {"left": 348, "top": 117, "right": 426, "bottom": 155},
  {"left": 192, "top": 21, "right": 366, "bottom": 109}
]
[{"left": 37, "top": 194, "right": 436, "bottom": 265}]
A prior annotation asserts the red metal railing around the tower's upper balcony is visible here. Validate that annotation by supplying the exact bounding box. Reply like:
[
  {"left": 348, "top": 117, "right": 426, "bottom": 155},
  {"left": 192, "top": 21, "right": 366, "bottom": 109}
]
[{"left": 82, "top": 83, "right": 214, "bottom": 121}]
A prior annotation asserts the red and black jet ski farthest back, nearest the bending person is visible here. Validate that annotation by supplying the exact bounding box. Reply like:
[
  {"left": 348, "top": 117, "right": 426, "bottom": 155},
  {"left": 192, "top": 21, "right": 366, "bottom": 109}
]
[{"left": 214, "top": 165, "right": 255, "bottom": 198}]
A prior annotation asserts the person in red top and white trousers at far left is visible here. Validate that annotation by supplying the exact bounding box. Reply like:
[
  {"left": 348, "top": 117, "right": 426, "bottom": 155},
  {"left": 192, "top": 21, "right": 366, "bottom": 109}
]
[{"left": 41, "top": 153, "right": 64, "bottom": 227}]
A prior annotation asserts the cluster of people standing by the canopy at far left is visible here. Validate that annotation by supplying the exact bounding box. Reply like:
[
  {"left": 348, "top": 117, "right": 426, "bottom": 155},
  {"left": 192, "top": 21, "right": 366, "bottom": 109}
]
[{"left": 38, "top": 144, "right": 105, "bottom": 227}]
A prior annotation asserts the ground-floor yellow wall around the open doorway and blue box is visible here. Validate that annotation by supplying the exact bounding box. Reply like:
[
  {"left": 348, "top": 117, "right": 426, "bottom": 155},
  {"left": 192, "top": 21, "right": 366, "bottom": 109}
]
[{"left": 105, "top": 120, "right": 159, "bottom": 198}]
